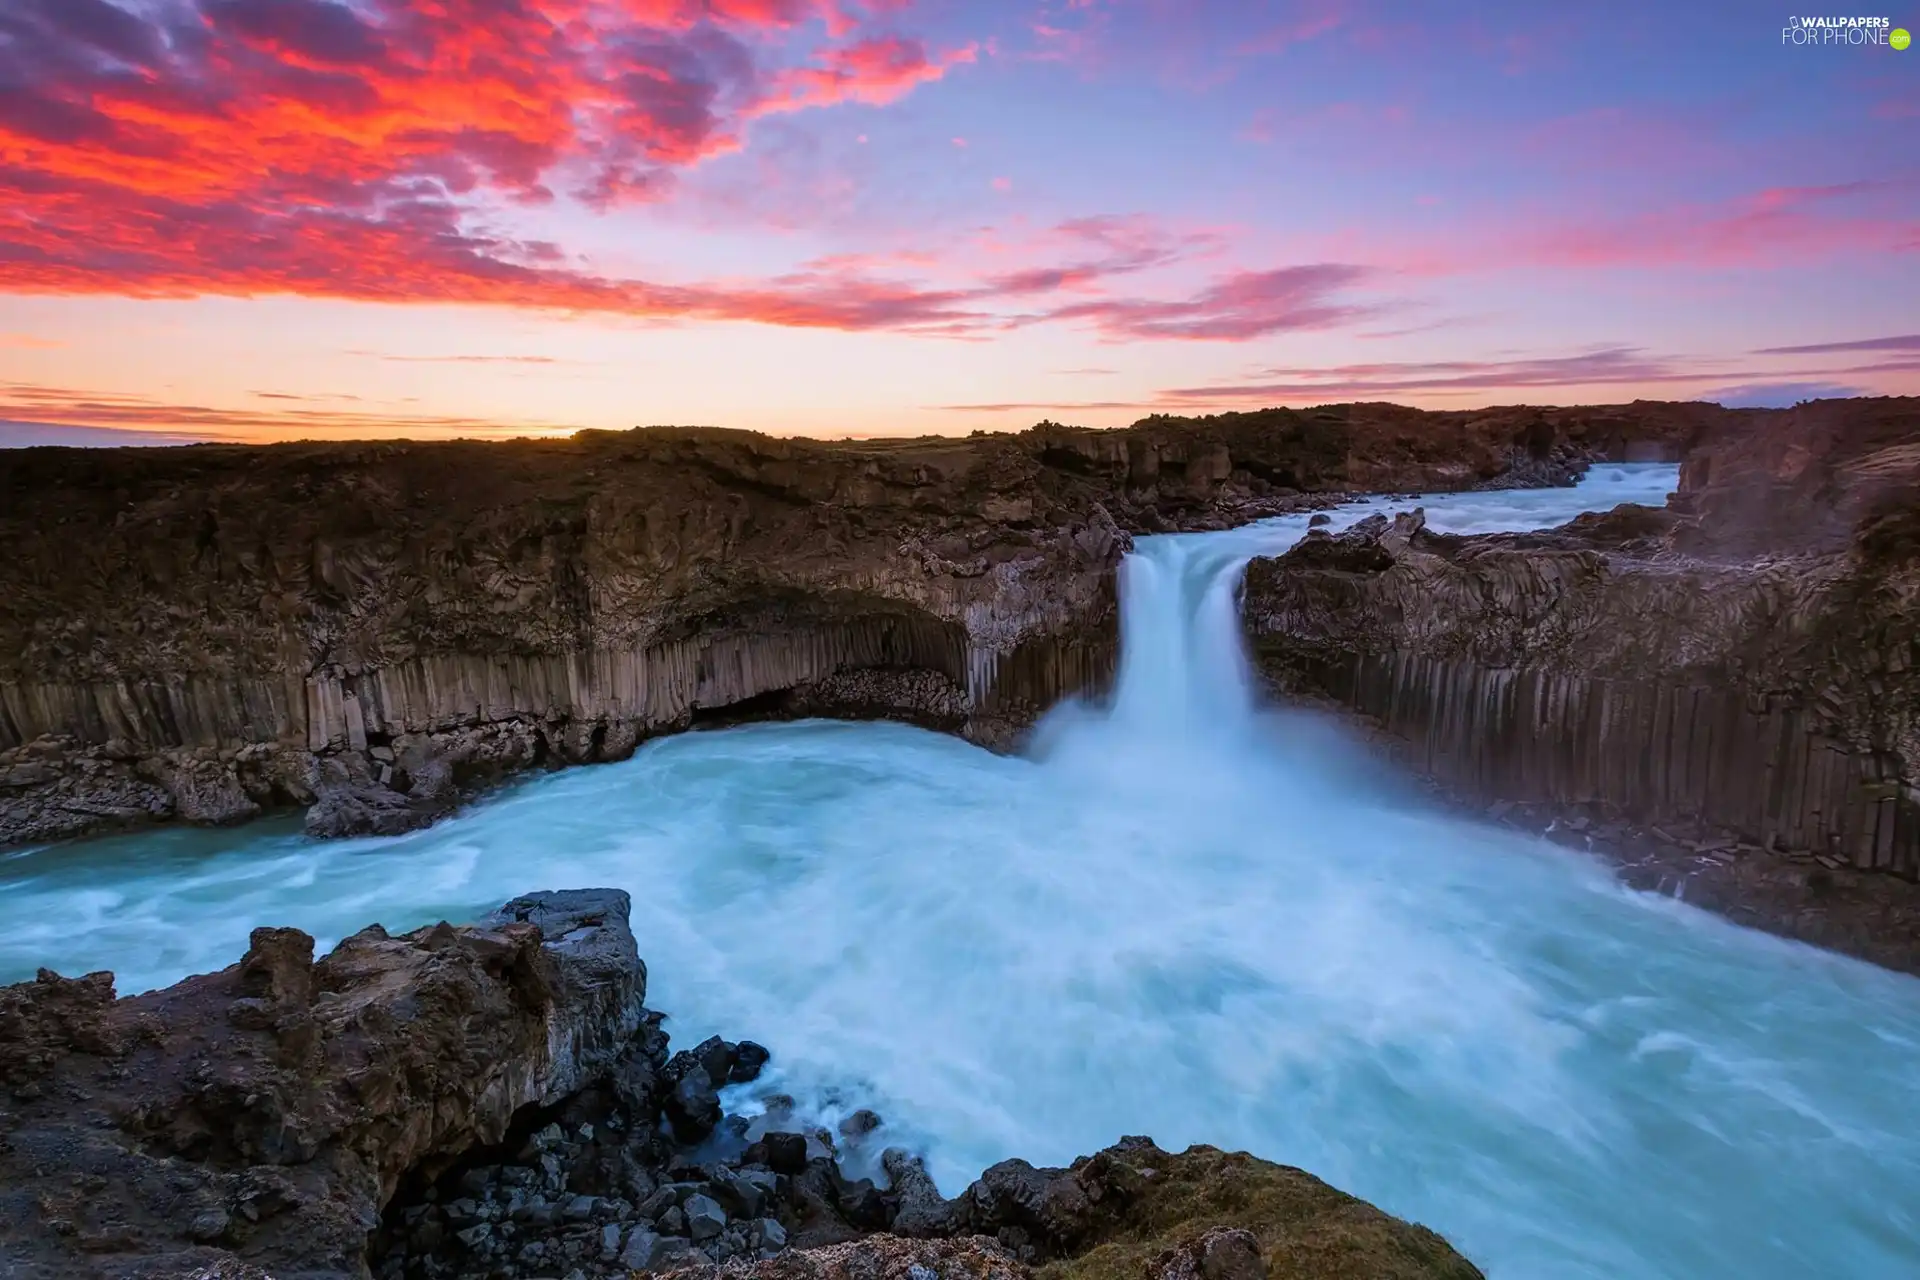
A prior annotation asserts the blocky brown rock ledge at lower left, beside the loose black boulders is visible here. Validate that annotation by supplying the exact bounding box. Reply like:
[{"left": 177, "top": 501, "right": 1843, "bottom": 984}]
[{"left": 0, "top": 890, "right": 645, "bottom": 1280}]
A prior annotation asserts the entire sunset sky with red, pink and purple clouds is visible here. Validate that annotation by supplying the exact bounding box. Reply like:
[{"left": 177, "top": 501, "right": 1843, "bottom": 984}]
[{"left": 0, "top": 0, "right": 1920, "bottom": 443}]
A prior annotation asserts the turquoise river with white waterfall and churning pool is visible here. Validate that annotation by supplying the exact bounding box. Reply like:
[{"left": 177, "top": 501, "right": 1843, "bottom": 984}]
[{"left": 0, "top": 466, "right": 1920, "bottom": 1280}]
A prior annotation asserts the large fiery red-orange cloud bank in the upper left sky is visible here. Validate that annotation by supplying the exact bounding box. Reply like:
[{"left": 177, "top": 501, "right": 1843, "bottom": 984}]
[{"left": 0, "top": 0, "right": 972, "bottom": 324}]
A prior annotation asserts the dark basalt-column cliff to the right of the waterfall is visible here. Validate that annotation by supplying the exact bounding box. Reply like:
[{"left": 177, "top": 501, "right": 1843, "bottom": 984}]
[{"left": 1244, "top": 399, "right": 1920, "bottom": 969}]
